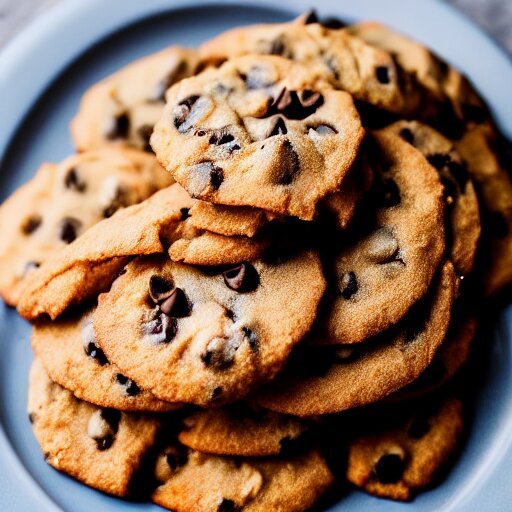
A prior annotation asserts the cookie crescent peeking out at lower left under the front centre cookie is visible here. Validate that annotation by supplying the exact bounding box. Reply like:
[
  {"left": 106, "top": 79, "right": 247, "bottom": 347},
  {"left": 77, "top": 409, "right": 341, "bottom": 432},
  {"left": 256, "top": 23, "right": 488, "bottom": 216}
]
[{"left": 31, "top": 311, "right": 179, "bottom": 412}]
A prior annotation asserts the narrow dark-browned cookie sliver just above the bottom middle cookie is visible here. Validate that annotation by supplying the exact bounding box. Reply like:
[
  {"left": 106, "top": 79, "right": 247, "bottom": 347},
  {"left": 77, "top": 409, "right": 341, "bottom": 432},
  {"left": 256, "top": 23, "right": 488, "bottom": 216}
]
[{"left": 178, "top": 403, "right": 308, "bottom": 457}]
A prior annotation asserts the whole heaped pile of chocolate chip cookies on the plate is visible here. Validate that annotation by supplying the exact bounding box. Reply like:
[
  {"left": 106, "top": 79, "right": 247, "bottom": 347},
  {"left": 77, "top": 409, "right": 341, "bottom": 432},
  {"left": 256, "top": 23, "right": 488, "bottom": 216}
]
[{"left": 0, "top": 13, "right": 512, "bottom": 512}]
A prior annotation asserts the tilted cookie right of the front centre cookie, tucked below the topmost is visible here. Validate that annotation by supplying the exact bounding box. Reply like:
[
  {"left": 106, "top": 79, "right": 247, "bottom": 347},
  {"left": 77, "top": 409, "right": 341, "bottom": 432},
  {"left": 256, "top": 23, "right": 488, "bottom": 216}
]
[{"left": 317, "top": 127, "right": 445, "bottom": 344}]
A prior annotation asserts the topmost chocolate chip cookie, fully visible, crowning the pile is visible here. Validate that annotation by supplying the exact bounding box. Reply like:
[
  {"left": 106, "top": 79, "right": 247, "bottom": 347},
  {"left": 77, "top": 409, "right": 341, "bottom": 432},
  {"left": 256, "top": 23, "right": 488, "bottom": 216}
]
[{"left": 151, "top": 56, "right": 363, "bottom": 220}]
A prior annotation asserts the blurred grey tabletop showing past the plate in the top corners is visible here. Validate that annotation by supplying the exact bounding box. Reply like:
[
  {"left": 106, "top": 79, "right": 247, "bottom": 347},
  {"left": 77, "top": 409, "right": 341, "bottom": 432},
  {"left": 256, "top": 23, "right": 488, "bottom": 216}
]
[{"left": 0, "top": 0, "right": 512, "bottom": 55}]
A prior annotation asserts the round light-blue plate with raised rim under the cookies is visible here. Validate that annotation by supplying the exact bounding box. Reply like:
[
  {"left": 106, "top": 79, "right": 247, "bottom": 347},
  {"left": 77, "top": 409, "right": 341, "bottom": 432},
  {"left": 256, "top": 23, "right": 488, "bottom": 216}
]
[{"left": 0, "top": 0, "right": 512, "bottom": 512}]
